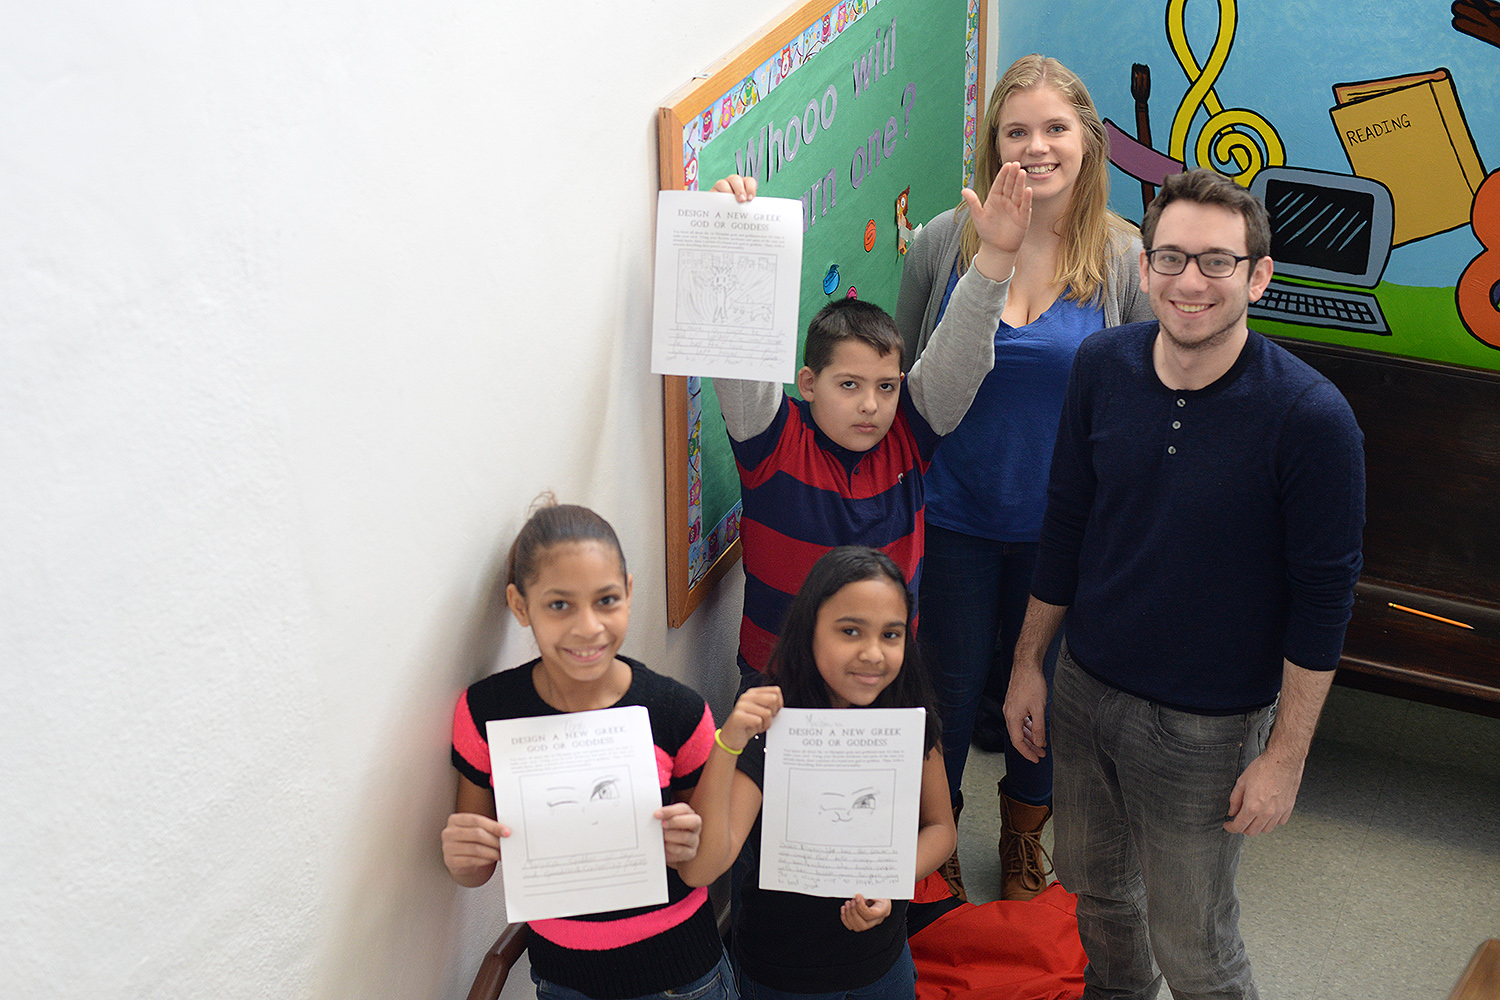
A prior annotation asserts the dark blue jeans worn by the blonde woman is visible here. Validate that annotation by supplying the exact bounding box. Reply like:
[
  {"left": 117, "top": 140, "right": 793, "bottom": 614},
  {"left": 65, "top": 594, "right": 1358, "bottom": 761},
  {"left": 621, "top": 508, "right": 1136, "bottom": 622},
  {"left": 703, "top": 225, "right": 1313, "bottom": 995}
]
[{"left": 917, "top": 525, "right": 1062, "bottom": 805}]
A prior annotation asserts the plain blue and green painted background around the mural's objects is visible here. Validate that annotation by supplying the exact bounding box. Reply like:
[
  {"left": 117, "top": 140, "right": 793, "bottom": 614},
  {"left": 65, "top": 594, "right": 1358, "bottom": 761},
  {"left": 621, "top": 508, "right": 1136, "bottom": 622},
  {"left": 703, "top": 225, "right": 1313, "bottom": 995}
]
[{"left": 990, "top": 0, "right": 1500, "bottom": 367}]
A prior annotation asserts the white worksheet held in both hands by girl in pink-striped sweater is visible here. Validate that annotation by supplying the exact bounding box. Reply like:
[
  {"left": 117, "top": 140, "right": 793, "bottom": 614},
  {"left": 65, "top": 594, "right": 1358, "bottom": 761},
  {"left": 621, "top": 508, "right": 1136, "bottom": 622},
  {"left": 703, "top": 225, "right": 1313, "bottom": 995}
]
[{"left": 486, "top": 705, "right": 668, "bottom": 922}]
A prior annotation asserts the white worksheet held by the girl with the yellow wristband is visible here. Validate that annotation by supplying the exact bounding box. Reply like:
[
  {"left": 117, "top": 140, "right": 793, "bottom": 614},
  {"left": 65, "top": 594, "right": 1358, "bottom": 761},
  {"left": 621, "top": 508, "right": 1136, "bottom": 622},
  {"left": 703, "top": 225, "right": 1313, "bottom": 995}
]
[{"left": 761, "top": 708, "right": 927, "bottom": 900}]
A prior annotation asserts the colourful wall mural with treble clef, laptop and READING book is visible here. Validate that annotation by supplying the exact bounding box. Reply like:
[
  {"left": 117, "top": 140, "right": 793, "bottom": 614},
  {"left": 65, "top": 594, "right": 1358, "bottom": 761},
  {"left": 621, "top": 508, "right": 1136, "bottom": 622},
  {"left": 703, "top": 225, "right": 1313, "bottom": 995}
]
[{"left": 992, "top": 0, "right": 1500, "bottom": 370}]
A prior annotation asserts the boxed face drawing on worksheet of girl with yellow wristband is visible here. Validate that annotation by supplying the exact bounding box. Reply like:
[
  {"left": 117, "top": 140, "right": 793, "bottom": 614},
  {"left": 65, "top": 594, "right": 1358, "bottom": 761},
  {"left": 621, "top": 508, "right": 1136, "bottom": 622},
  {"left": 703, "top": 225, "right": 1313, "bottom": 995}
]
[{"left": 786, "top": 768, "right": 896, "bottom": 847}]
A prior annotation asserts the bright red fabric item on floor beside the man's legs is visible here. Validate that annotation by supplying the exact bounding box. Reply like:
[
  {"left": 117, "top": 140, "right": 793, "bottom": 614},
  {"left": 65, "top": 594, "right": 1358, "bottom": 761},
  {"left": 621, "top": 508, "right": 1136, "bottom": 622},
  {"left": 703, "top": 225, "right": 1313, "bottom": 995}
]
[{"left": 911, "top": 883, "right": 1088, "bottom": 1000}]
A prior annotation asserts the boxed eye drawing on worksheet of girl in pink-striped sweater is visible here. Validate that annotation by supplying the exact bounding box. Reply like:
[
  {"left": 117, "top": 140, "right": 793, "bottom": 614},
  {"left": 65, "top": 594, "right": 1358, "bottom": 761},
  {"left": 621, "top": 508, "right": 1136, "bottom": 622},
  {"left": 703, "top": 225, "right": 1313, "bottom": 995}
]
[{"left": 521, "top": 771, "right": 636, "bottom": 861}]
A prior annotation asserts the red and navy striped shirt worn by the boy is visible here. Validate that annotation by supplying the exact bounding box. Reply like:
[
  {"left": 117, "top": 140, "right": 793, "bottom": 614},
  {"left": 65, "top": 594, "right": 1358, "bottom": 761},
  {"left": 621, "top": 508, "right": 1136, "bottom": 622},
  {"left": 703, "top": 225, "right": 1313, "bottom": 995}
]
[{"left": 729, "top": 389, "right": 942, "bottom": 673}]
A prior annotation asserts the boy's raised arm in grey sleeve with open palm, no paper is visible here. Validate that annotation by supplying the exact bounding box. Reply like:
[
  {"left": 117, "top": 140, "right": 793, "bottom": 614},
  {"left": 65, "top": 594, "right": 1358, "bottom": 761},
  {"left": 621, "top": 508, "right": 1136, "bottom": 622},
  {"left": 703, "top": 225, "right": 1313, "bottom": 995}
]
[{"left": 906, "top": 163, "right": 1031, "bottom": 435}]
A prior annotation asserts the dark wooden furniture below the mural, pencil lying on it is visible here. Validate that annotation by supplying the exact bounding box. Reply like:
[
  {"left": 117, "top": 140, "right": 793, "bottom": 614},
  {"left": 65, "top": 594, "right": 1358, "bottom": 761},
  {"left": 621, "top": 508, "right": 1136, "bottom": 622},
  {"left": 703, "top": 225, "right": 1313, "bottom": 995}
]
[{"left": 1277, "top": 337, "right": 1500, "bottom": 717}]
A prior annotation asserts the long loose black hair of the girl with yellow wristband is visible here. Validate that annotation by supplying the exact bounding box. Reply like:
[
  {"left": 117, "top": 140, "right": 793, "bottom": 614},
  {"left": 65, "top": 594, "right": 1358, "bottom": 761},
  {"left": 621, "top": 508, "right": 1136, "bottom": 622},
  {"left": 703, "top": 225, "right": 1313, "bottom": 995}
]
[{"left": 767, "top": 546, "right": 942, "bottom": 751}]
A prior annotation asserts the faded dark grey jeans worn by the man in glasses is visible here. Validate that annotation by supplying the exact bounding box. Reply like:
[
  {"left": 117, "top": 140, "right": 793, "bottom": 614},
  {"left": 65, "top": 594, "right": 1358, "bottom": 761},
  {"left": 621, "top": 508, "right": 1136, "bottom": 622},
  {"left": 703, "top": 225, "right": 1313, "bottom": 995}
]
[{"left": 1050, "top": 646, "right": 1275, "bottom": 1000}]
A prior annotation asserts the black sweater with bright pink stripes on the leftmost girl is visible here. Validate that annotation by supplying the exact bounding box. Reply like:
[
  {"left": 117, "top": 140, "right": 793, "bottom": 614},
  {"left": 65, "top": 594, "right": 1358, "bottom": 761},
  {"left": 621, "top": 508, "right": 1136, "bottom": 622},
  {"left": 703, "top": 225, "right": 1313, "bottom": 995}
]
[{"left": 453, "top": 657, "right": 723, "bottom": 1000}]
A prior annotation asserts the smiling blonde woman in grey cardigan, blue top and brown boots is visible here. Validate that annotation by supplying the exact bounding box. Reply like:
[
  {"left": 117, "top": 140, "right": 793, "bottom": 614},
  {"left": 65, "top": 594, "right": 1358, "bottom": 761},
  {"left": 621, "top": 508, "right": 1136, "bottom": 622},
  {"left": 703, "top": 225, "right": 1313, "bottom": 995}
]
[{"left": 896, "top": 55, "right": 1152, "bottom": 900}]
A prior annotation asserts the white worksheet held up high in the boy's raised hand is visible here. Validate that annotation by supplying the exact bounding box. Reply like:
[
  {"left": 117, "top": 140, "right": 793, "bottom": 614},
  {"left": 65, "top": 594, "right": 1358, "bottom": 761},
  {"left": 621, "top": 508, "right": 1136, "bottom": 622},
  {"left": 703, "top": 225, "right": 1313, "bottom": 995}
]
[{"left": 651, "top": 190, "right": 803, "bottom": 382}]
